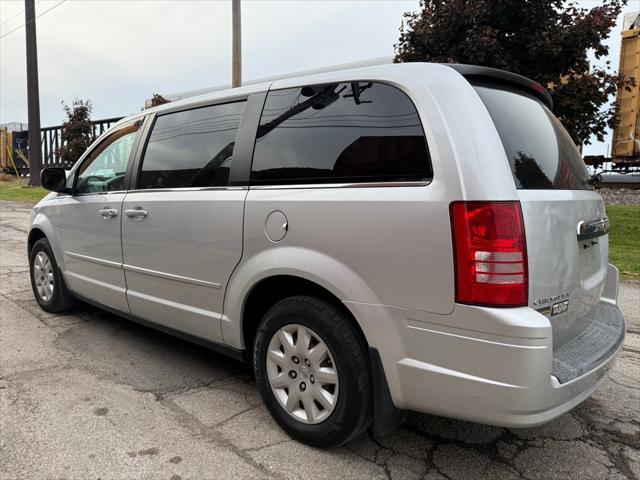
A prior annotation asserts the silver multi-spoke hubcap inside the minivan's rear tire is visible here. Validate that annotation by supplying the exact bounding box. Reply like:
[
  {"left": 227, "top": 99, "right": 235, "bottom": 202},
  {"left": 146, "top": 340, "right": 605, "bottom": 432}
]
[{"left": 267, "top": 324, "right": 339, "bottom": 424}]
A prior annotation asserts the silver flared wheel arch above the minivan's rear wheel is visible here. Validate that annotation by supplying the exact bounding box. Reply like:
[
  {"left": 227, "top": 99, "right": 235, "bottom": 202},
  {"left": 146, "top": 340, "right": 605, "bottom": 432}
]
[{"left": 222, "top": 246, "right": 380, "bottom": 349}]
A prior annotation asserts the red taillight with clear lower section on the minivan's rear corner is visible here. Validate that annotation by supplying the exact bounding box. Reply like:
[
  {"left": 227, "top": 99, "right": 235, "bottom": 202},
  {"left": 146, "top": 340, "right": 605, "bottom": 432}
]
[{"left": 450, "top": 202, "right": 528, "bottom": 307}]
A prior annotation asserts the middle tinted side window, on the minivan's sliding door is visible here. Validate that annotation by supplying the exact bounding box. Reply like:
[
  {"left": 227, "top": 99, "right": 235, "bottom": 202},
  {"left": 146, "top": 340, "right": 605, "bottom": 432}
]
[{"left": 138, "top": 102, "right": 246, "bottom": 189}]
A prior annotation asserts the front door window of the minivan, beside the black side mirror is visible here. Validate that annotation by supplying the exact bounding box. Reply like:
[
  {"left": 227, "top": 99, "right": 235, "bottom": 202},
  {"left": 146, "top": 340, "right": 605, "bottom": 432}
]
[{"left": 75, "top": 122, "right": 142, "bottom": 194}]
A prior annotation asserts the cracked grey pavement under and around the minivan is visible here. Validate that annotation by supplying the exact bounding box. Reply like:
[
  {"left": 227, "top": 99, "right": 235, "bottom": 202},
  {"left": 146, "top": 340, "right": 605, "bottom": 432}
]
[{"left": 0, "top": 202, "right": 640, "bottom": 480}]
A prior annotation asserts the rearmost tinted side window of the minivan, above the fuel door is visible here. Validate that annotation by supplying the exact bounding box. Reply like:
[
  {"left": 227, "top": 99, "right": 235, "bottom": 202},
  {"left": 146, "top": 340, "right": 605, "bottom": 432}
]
[{"left": 251, "top": 82, "right": 432, "bottom": 184}]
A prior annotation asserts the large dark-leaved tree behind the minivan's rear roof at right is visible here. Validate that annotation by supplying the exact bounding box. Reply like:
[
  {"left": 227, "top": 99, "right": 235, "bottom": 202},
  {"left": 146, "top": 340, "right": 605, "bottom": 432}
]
[{"left": 395, "top": 0, "right": 635, "bottom": 145}]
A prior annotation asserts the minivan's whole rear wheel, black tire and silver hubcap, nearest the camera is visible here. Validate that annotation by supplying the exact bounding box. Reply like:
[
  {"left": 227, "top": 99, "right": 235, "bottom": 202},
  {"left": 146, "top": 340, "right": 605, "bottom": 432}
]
[{"left": 253, "top": 296, "right": 371, "bottom": 447}]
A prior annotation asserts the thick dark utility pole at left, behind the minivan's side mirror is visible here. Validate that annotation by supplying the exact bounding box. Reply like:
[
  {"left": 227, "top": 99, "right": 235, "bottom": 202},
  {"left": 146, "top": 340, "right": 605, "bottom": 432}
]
[{"left": 24, "top": 0, "right": 42, "bottom": 186}]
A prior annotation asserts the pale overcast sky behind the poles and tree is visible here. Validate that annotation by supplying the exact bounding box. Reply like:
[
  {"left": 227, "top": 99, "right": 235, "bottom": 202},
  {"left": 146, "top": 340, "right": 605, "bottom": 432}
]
[{"left": 0, "top": 0, "right": 640, "bottom": 154}]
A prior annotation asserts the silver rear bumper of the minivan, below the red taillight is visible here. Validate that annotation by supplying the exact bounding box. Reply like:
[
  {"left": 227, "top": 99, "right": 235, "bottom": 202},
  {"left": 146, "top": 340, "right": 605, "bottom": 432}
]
[{"left": 345, "top": 274, "right": 625, "bottom": 427}]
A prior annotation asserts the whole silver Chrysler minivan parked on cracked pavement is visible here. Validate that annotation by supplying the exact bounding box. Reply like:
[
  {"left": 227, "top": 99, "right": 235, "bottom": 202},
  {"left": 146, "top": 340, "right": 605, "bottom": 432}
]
[{"left": 28, "top": 63, "right": 625, "bottom": 447}]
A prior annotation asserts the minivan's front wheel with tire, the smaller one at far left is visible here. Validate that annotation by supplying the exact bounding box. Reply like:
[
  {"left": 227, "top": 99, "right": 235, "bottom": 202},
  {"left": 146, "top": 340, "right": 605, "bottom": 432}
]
[{"left": 29, "top": 238, "right": 75, "bottom": 313}]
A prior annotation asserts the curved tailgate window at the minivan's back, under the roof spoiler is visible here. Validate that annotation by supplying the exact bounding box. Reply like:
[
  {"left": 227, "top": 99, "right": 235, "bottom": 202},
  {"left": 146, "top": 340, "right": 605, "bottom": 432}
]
[{"left": 475, "top": 85, "right": 593, "bottom": 190}]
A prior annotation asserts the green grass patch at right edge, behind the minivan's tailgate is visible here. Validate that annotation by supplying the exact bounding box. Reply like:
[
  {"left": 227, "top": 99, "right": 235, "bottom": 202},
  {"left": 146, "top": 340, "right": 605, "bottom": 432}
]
[{"left": 607, "top": 205, "right": 640, "bottom": 279}]
